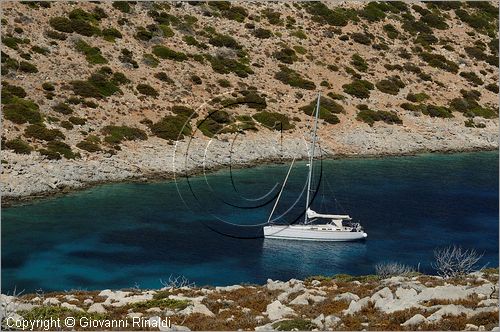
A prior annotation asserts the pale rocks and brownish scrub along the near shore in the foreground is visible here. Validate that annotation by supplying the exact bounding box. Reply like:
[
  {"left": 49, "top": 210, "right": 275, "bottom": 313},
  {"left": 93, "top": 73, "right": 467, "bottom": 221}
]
[{"left": 1, "top": 269, "right": 498, "bottom": 331}]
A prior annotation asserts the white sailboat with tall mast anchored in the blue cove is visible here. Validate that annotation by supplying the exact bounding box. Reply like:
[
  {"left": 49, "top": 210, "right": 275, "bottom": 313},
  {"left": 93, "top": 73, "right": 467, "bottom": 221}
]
[{"left": 264, "top": 92, "right": 368, "bottom": 241}]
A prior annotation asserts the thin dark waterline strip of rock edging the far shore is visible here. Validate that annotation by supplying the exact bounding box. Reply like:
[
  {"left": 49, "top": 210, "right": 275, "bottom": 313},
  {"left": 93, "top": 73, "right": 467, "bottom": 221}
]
[{"left": 1, "top": 147, "right": 498, "bottom": 208}]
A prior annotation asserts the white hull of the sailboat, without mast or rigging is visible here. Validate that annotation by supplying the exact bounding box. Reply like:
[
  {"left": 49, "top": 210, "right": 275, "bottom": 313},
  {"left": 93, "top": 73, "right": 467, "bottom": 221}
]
[{"left": 264, "top": 225, "right": 368, "bottom": 241}]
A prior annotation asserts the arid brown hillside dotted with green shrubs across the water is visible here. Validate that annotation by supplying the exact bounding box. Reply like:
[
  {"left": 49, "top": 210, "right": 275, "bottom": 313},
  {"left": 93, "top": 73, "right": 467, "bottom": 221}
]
[{"left": 1, "top": 1, "right": 498, "bottom": 197}]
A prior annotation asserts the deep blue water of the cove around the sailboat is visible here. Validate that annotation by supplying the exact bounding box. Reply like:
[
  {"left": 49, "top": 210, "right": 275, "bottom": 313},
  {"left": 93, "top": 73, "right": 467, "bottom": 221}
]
[{"left": 1, "top": 152, "right": 499, "bottom": 293}]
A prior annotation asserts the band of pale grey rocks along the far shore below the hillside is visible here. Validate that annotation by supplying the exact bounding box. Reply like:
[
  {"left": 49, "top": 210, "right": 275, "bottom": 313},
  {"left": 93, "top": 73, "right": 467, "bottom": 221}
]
[{"left": 1, "top": 128, "right": 498, "bottom": 206}]
